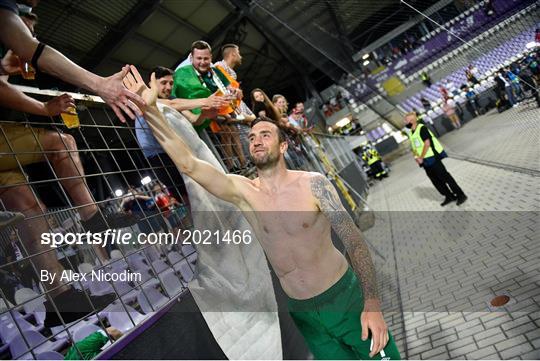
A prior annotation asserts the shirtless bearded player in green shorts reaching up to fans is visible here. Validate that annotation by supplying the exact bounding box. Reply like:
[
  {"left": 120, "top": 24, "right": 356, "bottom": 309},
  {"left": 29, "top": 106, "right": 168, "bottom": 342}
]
[{"left": 124, "top": 67, "right": 400, "bottom": 360}]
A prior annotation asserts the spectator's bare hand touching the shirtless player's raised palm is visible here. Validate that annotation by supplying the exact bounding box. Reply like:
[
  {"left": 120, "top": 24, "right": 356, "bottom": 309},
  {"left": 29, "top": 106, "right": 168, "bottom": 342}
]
[{"left": 100, "top": 65, "right": 145, "bottom": 123}]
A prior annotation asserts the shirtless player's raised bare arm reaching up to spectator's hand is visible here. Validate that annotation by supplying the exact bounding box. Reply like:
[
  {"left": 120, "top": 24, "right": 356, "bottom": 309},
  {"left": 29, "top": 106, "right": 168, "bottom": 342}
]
[{"left": 124, "top": 66, "right": 246, "bottom": 206}]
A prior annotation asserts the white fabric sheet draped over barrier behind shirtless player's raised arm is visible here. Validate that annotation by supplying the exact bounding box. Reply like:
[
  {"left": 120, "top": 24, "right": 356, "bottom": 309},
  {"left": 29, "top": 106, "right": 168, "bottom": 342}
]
[{"left": 160, "top": 105, "right": 283, "bottom": 360}]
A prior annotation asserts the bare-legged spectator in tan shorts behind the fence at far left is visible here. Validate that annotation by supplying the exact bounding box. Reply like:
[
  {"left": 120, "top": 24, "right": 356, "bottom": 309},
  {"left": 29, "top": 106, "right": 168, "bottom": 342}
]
[{"left": 0, "top": 80, "right": 139, "bottom": 326}]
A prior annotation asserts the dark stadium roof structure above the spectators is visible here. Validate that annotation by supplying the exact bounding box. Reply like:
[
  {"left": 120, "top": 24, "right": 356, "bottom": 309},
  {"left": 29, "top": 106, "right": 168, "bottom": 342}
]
[{"left": 34, "top": 0, "right": 432, "bottom": 100}]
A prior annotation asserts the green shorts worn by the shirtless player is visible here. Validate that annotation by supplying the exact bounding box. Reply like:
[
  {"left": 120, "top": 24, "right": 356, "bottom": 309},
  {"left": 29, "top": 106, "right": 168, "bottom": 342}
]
[{"left": 288, "top": 267, "right": 400, "bottom": 360}]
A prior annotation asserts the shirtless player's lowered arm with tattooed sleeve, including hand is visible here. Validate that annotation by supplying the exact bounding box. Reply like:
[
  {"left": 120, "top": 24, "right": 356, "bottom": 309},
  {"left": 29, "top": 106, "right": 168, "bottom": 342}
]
[{"left": 310, "top": 174, "right": 389, "bottom": 357}]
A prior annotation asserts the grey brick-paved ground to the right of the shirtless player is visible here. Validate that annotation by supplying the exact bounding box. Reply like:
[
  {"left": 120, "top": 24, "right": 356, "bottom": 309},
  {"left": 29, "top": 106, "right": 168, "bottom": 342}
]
[{"left": 365, "top": 106, "right": 540, "bottom": 359}]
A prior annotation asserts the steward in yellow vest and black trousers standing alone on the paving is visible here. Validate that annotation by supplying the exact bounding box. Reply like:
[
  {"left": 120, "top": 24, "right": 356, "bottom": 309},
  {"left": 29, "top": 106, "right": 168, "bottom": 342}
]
[{"left": 405, "top": 112, "right": 467, "bottom": 207}]
